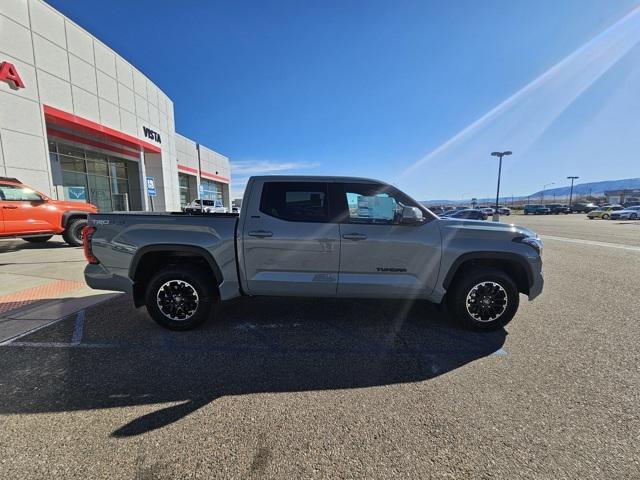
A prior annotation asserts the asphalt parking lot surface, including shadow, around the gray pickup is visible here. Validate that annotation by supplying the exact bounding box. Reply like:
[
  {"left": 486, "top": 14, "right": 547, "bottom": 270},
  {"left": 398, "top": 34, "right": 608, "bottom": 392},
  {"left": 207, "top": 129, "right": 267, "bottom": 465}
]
[{"left": 0, "top": 215, "right": 640, "bottom": 479}]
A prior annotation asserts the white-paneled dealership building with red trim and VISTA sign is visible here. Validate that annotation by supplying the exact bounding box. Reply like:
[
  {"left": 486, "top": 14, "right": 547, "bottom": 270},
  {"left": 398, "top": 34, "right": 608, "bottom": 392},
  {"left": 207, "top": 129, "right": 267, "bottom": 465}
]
[{"left": 0, "top": 0, "right": 231, "bottom": 212}]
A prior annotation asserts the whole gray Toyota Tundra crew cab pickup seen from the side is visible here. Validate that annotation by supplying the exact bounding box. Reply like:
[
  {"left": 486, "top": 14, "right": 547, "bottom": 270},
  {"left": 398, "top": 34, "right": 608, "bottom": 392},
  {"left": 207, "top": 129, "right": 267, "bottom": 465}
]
[{"left": 84, "top": 176, "right": 543, "bottom": 330}]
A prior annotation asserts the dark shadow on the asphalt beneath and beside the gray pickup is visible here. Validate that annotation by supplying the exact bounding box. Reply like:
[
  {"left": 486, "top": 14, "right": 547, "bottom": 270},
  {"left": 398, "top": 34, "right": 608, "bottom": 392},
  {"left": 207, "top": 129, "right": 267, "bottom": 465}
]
[{"left": 0, "top": 297, "right": 506, "bottom": 437}]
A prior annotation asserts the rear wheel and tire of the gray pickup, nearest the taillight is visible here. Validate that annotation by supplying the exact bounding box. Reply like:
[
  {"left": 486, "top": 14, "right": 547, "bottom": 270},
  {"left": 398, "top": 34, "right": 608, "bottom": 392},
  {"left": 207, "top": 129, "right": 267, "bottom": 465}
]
[{"left": 145, "top": 265, "right": 218, "bottom": 330}]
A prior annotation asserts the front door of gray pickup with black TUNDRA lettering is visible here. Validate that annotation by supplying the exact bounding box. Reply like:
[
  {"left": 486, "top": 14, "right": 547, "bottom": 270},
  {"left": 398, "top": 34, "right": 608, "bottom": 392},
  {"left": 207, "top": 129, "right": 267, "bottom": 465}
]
[{"left": 332, "top": 183, "right": 441, "bottom": 298}]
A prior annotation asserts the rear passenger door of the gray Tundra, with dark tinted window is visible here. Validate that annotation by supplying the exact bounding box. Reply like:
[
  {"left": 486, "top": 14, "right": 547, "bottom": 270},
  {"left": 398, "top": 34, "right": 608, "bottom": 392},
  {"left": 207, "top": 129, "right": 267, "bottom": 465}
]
[{"left": 241, "top": 180, "right": 340, "bottom": 296}]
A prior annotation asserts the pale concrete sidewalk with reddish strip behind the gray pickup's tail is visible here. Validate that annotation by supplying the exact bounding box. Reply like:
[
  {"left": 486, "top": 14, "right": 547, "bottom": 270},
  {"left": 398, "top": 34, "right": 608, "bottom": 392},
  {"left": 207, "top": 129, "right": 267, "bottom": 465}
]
[{"left": 0, "top": 236, "right": 119, "bottom": 343}]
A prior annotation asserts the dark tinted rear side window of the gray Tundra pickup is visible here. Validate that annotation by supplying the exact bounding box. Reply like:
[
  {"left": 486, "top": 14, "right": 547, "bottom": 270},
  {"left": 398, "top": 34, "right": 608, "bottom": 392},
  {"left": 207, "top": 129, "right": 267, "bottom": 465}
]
[{"left": 260, "top": 182, "right": 329, "bottom": 222}]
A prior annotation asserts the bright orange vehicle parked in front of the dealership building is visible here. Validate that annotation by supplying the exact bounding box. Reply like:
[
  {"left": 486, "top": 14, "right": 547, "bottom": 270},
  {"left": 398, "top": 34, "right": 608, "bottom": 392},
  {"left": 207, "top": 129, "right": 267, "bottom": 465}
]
[{"left": 0, "top": 177, "right": 98, "bottom": 246}]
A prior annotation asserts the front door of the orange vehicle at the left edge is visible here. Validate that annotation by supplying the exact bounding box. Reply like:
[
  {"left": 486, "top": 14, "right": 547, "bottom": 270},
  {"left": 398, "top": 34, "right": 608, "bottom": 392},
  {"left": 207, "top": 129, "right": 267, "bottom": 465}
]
[{"left": 0, "top": 184, "right": 53, "bottom": 235}]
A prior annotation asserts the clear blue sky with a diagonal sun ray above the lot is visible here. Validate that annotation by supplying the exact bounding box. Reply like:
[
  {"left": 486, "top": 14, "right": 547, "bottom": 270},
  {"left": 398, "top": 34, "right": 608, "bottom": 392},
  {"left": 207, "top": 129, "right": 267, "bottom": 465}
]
[{"left": 48, "top": 0, "right": 640, "bottom": 200}]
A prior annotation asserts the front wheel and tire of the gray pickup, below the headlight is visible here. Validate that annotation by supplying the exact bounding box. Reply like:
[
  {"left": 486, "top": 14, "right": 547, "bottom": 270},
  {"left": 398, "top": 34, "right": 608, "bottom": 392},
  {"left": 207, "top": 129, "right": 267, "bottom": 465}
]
[{"left": 447, "top": 267, "right": 520, "bottom": 331}]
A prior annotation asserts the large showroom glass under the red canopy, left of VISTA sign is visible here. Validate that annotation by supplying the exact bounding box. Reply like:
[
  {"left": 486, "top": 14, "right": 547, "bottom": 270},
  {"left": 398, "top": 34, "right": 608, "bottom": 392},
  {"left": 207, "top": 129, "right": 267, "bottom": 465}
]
[{"left": 49, "top": 141, "right": 137, "bottom": 212}]
